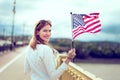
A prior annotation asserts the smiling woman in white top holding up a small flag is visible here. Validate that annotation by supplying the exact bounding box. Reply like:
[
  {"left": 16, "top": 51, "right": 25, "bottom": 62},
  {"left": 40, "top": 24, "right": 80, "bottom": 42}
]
[{"left": 25, "top": 20, "right": 75, "bottom": 80}]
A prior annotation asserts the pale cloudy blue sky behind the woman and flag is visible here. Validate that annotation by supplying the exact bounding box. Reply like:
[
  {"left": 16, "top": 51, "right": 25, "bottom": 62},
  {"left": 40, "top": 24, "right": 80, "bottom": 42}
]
[{"left": 0, "top": 0, "right": 120, "bottom": 42}]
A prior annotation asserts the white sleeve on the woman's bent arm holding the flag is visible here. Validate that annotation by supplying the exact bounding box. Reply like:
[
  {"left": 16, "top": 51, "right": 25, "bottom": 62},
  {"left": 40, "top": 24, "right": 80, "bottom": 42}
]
[{"left": 43, "top": 46, "right": 67, "bottom": 80}]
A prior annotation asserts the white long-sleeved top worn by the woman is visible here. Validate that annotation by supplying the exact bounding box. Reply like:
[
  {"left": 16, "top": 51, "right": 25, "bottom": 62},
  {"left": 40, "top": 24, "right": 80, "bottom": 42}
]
[{"left": 24, "top": 44, "right": 67, "bottom": 80}]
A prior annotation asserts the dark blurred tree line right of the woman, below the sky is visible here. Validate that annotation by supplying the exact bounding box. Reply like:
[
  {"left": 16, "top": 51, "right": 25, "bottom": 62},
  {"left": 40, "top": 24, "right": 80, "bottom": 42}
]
[{"left": 50, "top": 38, "right": 120, "bottom": 59}]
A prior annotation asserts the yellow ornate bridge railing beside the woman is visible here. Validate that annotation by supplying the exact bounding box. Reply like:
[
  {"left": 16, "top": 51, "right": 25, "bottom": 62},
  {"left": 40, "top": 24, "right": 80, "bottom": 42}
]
[{"left": 57, "top": 54, "right": 103, "bottom": 80}]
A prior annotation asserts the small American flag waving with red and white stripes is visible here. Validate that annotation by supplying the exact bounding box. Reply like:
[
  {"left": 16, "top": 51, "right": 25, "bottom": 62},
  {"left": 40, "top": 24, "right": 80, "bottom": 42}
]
[{"left": 71, "top": 13, "right": 101, "bottom": 39}]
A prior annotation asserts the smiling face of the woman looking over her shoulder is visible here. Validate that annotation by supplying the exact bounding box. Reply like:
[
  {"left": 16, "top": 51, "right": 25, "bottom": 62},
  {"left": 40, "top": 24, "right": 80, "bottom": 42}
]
[{"left": 38, "top": 25, "right": 51, "bottom": 43}]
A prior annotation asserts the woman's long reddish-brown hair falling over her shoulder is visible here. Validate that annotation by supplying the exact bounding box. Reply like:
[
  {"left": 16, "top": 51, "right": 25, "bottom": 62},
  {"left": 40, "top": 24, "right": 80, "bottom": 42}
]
[{"left": 29, "top": 20, "right": 52, "bottom": 49}]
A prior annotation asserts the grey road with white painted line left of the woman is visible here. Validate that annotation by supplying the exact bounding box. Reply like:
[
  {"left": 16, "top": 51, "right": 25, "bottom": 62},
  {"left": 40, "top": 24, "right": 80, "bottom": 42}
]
[{"left": 0, "top": 47, "right": 30, "bottom": 80}]
